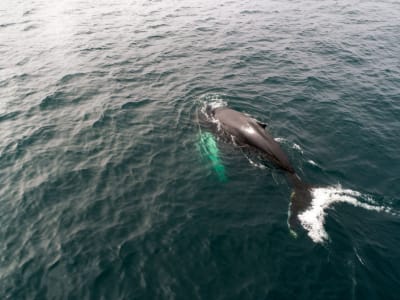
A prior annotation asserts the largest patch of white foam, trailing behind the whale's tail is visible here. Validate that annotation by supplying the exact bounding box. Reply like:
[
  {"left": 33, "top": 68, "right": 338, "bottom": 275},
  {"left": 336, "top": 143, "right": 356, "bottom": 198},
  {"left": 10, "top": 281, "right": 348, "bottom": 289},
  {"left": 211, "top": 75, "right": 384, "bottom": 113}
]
[{"left": 298, "top": 185, "right": 389, "bottom": 243}]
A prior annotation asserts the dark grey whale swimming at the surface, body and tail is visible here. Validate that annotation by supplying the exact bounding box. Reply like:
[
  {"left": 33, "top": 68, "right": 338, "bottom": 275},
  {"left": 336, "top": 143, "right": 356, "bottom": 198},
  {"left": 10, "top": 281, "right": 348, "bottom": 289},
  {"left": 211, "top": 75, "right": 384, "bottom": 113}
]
[{"left": 200, "top": 106, "right": 312, "bottom": 235}]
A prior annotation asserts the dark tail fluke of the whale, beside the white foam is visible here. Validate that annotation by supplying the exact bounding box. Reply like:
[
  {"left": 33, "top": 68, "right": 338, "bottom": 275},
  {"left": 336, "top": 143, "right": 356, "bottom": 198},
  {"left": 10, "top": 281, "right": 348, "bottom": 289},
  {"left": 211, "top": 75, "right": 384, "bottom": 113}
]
[{"left": 288, "top": 173, "right": 312, "bottom": 234}]
